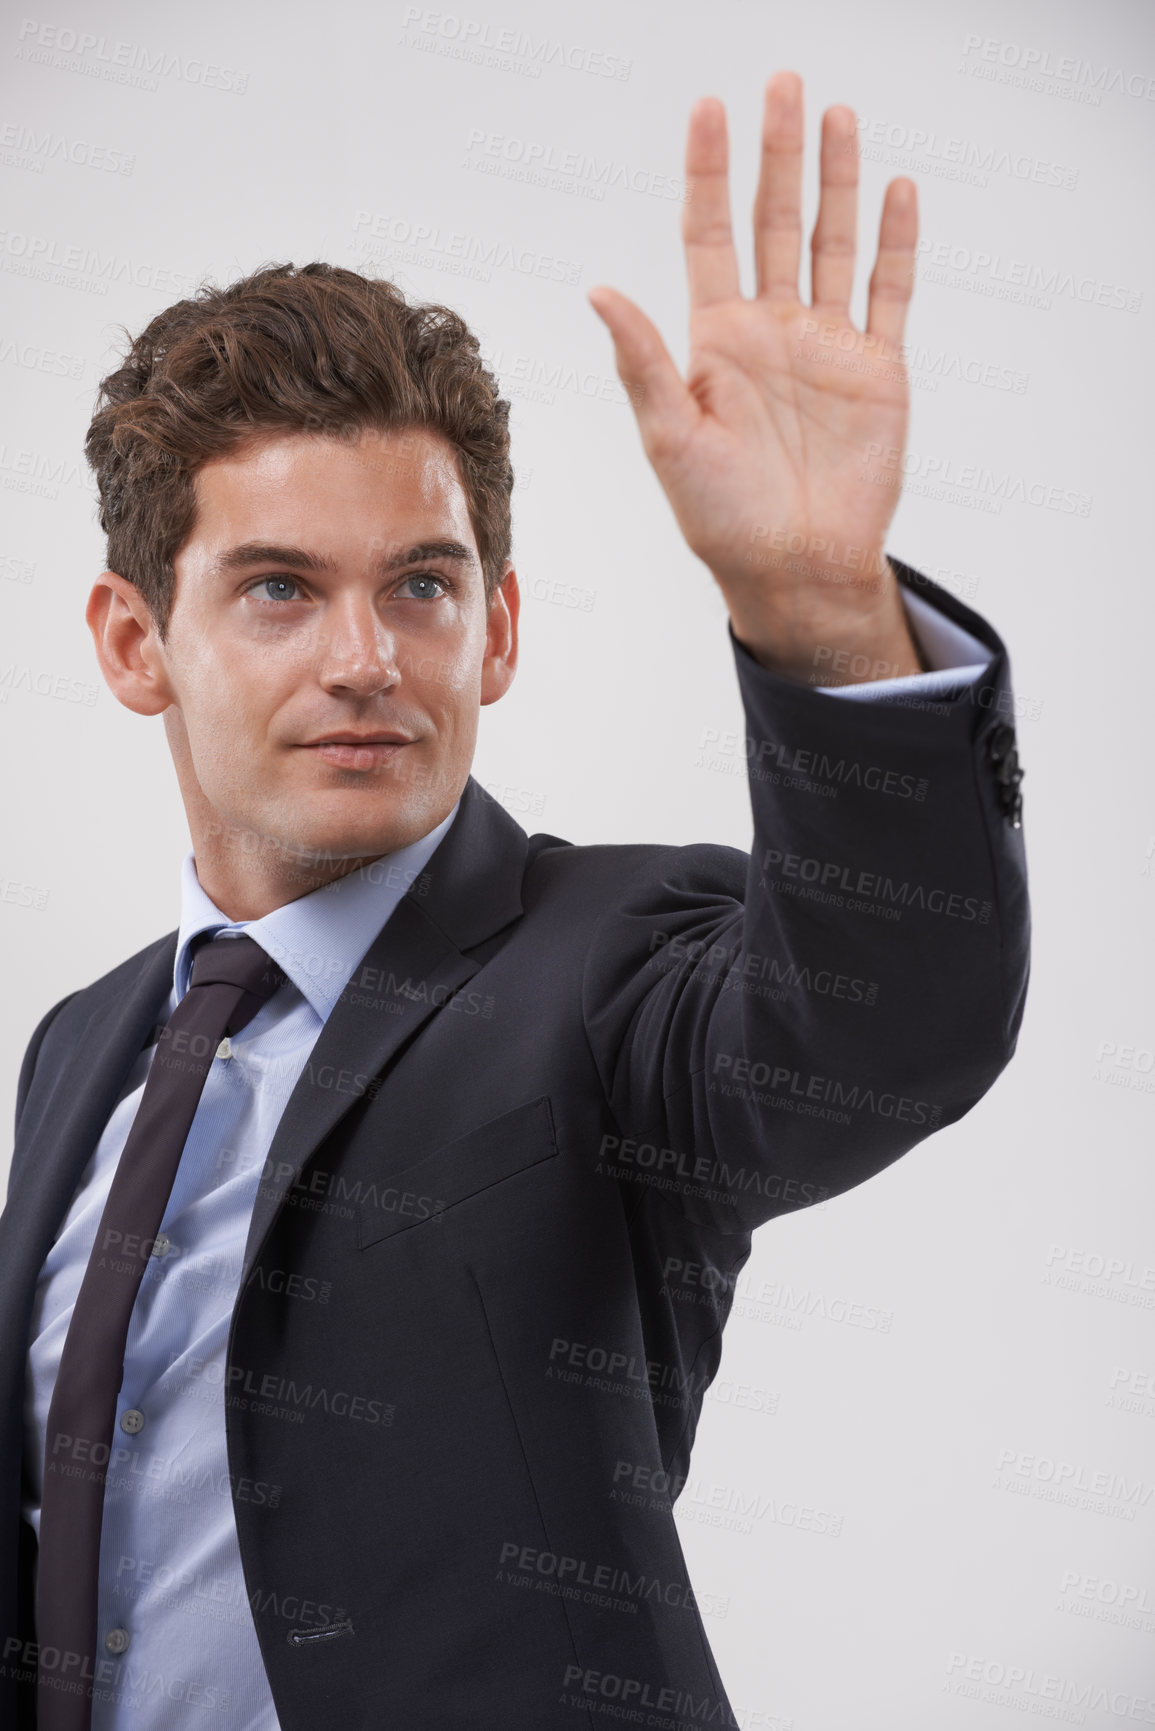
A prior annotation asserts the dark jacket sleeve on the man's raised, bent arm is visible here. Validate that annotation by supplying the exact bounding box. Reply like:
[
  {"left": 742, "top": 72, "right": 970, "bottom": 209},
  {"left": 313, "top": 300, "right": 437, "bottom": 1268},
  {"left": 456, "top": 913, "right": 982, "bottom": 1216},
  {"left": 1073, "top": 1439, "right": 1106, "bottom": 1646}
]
[{"left": 582, "top": 559, "right": 1030, "bottom": 1232}]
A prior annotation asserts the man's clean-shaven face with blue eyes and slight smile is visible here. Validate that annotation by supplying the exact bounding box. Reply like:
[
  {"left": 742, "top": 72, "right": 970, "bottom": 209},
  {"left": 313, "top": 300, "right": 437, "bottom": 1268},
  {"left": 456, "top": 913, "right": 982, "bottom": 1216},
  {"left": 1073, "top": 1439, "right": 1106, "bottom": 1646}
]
[{"left": 115, "top": 431, "right": 518, "bottom": 881}]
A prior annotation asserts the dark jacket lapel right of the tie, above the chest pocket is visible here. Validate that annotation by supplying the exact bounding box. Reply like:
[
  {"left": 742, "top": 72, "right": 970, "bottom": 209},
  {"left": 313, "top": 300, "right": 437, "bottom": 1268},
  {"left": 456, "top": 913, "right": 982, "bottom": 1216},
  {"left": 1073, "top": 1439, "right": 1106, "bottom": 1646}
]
[{"left": 241, "top": 775, "right": 528, "bottom": 1291}]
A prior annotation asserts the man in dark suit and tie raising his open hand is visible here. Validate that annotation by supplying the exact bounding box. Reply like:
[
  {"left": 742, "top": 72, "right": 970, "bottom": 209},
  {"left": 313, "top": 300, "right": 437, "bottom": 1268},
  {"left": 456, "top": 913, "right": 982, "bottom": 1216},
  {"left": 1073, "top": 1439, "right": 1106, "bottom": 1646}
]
[{"left": 0, "top": 74, "right": 1029, "bottom": 1731}]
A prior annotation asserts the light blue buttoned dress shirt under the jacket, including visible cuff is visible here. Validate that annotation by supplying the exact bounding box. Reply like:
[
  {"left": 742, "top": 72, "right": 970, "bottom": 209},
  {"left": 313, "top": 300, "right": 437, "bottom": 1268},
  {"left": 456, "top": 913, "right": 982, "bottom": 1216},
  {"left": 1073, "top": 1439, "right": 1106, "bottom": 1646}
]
[{"left": 24, "top": 594, "right": 990, "bottom": 1731}]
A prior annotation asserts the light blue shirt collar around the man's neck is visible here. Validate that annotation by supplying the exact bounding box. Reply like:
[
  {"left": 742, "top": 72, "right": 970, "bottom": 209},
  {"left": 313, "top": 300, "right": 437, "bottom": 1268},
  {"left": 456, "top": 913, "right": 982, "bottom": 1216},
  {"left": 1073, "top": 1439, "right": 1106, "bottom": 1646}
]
[{"left": 173, "top": 800, "right": 461, "bottom": 1021}]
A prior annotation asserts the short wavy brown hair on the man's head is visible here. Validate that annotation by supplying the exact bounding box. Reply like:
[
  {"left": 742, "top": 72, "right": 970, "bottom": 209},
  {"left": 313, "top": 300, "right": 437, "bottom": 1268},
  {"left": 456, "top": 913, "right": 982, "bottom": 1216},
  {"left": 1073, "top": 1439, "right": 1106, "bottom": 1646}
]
[{"left": 85, "top": 263, "right": 513, "bottom": 640}]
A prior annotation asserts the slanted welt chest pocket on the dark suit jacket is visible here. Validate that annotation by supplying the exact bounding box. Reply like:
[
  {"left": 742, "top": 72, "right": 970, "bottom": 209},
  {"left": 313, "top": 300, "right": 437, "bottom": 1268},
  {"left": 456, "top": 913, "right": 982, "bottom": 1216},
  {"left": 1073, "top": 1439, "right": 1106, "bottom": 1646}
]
[{"left": 357, "top": 1094, "right": 558, "bottom": 1250}]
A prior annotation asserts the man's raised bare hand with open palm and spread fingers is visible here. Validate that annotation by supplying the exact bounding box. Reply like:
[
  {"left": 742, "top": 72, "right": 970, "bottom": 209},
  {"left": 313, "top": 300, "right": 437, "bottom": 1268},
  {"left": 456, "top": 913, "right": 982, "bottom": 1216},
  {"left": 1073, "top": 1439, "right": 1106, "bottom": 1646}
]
[{"left": 589, "top": 73, "right": 919, "bottom": 673}]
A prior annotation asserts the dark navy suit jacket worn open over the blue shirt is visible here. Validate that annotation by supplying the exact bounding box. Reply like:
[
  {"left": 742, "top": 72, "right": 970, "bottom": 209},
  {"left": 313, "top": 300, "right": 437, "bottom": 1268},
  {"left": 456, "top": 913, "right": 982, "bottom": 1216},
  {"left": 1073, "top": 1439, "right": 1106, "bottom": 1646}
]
[{"left": 0, "top": 566, "right": 1029, "bottom": 1731}]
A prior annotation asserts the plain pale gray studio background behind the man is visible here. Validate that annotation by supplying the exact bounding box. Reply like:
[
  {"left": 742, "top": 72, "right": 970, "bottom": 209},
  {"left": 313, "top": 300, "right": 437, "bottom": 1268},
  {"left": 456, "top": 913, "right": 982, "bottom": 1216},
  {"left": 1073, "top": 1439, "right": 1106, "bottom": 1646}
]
[{"left": 0, "top": 0, "right": 1155, "bottom": 1731}]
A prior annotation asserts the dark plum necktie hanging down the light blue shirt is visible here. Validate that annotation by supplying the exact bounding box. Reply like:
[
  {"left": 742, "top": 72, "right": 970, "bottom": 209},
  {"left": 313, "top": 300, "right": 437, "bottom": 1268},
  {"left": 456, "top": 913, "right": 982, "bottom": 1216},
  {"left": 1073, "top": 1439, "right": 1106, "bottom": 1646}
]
[{"left": 36, "top": 935, "right": 286, "bottom": 1731}]
